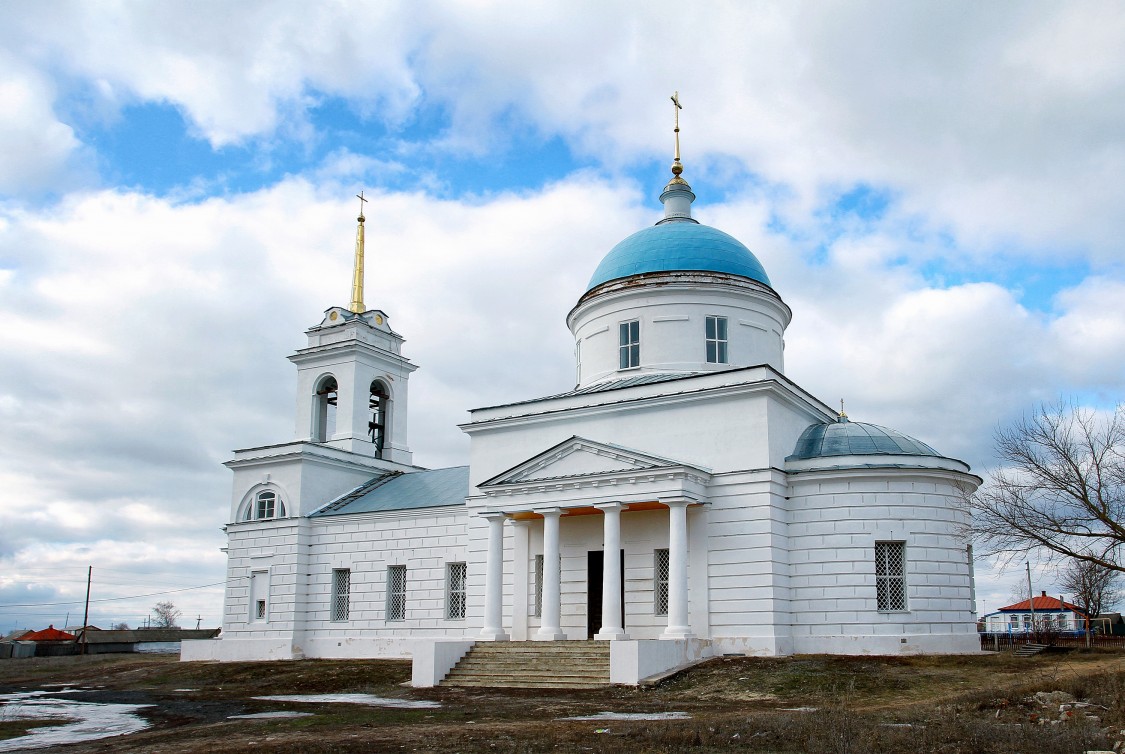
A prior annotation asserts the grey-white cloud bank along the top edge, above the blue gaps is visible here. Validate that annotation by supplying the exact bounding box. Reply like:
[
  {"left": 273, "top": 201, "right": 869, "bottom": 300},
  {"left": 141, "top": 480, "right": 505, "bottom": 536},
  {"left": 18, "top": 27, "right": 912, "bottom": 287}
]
[{"left": 0, "top": 2, "right": 1125, "bottom": 259}]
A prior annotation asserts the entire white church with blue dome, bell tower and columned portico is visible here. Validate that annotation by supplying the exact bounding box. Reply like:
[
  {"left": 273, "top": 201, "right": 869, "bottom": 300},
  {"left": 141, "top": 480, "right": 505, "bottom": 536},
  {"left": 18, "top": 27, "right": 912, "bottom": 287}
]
[{"left": 182, "top": 127, "right": 980, "bottom": 685}]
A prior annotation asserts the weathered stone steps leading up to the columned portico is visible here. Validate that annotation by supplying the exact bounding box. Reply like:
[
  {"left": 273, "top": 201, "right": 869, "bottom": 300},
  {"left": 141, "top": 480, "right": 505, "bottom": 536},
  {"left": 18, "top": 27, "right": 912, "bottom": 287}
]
[{"left": 441, "top": 641, "right": 610, "bottom": 689}]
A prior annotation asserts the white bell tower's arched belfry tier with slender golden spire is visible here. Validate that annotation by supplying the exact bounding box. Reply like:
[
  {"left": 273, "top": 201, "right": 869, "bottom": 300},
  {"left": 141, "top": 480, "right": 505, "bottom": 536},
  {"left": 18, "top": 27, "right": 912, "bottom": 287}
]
[{"left": 289, "top": 194, "right": 417, "bottom": 465}]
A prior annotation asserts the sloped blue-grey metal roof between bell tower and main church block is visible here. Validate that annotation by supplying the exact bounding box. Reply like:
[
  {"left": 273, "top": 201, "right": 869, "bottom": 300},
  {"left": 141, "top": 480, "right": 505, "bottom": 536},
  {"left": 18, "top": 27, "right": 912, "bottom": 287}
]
[{"left": 308, "top": 466, "right": 469, "bottom": 518}]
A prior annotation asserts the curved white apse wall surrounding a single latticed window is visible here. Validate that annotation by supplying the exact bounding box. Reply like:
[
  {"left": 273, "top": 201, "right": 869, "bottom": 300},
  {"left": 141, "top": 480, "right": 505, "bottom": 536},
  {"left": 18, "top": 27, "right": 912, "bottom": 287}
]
[{"left": 789, "top": 468, "right": 979, "bottom": 654}]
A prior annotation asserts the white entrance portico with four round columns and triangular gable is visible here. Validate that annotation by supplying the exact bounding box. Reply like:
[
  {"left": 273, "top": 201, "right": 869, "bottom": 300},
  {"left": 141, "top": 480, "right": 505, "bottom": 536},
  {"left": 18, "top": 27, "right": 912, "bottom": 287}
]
[{"left": 469, "top": 437, "right": 710, "bottom": 641}]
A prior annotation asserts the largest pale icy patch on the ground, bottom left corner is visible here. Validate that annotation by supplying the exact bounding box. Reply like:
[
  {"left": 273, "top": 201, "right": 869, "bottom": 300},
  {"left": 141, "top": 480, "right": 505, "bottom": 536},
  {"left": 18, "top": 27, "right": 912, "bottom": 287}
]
[{"left": 0, "top": 691, "right": 152, "bottom": 752}]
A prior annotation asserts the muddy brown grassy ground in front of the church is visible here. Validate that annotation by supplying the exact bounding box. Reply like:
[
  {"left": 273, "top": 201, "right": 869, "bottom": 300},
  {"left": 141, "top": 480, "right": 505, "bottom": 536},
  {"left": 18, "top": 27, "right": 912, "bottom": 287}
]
[{"left": 0, "top": 652, "right": 1125, "bottom": 754}]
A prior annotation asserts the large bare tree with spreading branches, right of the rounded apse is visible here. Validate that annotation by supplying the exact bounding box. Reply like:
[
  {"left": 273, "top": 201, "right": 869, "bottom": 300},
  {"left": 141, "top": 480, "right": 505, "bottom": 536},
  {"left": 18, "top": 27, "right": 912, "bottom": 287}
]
[{"left": 971, "top": 403, "right": 1125, "bottom": 571}]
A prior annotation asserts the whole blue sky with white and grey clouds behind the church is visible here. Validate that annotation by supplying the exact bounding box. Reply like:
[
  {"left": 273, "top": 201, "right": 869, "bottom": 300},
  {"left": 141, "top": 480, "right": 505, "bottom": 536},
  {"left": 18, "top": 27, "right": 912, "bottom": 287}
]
[{"left": 0, "top": 0, "right": 1125, "bottom": 632}]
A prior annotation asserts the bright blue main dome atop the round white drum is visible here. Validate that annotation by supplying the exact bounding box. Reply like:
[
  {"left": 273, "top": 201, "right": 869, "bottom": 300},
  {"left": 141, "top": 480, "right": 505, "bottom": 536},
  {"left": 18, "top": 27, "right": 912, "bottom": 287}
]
[{"left": 586, "top": 222, "right": 770, "bottom": 290}]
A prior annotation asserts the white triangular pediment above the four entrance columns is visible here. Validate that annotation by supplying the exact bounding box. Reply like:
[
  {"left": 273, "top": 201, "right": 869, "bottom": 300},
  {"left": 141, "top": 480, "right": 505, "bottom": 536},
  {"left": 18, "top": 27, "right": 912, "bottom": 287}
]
[{"left": 479, "top": 437, "right": 693, "bottom": 487}]
